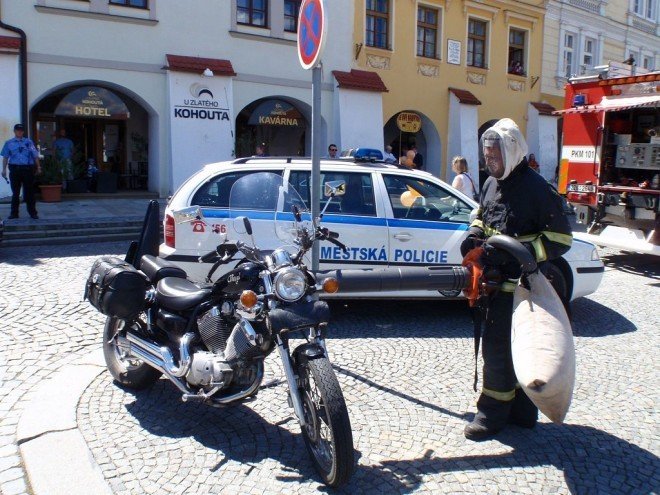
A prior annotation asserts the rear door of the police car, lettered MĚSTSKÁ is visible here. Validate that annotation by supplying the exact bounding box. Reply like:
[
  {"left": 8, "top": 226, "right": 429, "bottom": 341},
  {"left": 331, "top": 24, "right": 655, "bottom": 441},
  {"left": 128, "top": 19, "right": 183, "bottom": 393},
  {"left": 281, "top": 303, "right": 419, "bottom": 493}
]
[{"left": 289, "top": 167, "right": 388, "bottom": 270}]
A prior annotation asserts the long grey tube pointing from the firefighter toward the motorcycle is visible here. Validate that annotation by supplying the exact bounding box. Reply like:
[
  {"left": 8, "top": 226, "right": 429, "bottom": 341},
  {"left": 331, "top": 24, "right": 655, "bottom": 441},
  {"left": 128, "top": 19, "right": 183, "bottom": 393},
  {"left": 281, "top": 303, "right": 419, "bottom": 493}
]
[{"left": 316, "top": 266, "right": 470, "bottom": 293}]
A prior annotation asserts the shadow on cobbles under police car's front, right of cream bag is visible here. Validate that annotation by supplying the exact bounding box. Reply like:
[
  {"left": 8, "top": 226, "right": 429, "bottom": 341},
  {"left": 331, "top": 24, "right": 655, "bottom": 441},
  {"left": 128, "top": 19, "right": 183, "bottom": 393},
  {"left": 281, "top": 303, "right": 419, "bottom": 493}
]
[{"left": 571, "top": 297, "right": 637, "bottom": 337}]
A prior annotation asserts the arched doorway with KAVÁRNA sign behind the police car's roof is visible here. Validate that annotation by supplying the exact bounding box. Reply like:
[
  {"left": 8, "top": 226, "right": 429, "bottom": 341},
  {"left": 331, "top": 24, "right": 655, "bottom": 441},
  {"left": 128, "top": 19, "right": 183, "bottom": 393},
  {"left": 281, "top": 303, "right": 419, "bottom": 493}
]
[{"left": 236, "top": 97, "right": 311, "bottom": 157}]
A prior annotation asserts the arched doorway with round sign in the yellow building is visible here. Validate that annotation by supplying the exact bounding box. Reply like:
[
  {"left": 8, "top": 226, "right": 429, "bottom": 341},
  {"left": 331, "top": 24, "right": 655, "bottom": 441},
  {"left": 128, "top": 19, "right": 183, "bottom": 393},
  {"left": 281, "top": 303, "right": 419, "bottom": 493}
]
[{"left": 383, "top": 110, "right": 442, "bottom": 176}]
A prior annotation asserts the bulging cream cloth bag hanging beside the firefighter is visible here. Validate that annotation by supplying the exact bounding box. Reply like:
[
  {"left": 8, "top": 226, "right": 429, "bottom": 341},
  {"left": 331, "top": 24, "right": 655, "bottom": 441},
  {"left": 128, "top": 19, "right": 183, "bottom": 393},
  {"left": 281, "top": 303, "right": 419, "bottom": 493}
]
[{"left": 511, "top": 271, "right": 575, "bottom": 423}]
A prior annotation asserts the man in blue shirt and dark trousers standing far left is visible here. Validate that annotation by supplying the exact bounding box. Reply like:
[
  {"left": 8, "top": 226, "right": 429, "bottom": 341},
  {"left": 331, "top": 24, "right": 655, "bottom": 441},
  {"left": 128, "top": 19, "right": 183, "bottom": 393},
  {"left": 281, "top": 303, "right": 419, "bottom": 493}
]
[{"left": 0, "top": 124, "right": 41, "bottom": 220}]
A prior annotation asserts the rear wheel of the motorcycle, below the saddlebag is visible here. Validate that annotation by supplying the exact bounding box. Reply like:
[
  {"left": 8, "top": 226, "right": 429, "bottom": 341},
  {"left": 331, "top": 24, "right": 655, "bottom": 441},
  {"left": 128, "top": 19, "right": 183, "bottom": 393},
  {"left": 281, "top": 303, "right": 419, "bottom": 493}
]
[{"left": 103, "top": 318, "right": 162, "bottom": 390}]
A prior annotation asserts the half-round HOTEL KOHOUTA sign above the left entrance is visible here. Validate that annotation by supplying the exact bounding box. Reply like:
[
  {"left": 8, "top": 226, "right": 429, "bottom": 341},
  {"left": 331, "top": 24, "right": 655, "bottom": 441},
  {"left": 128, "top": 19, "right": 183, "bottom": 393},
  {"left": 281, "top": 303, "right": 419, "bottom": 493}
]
[{"left": 55, "top": 86, "right": 130, "bottom": 120}]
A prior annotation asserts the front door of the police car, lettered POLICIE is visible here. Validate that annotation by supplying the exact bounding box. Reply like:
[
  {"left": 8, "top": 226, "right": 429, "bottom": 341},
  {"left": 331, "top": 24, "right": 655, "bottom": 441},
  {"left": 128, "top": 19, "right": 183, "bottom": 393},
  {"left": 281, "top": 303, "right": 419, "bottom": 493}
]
[{"left": 382, "top": 173, "right": 473, "bottom": 266}]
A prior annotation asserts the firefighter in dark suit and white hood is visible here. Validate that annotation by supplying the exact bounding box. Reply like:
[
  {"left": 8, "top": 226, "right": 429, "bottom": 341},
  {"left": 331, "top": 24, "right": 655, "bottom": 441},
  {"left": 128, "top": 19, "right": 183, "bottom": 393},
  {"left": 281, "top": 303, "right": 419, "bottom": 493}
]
[{"left": 461, "top": 119, "right": 572, "bottom": 440}]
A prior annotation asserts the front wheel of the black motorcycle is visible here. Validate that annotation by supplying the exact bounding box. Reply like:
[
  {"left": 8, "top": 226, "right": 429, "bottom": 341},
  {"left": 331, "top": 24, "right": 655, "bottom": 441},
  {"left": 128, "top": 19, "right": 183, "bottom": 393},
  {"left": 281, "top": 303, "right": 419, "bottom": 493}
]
[{"left": 298, "top": 358, "right": 354, "bottom": 487}]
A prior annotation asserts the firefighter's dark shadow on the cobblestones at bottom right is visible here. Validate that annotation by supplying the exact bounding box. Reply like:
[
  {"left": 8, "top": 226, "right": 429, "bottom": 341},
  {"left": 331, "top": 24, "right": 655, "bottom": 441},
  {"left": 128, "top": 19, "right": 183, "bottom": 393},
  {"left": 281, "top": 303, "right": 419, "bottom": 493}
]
[{"left": 345, "top": 423, "right": 660, "bottom": 494}]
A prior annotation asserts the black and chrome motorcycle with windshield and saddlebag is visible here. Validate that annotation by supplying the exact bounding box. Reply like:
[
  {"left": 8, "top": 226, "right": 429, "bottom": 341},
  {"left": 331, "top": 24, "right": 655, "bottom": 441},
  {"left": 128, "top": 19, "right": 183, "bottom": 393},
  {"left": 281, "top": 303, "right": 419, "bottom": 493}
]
[{"left": 87, "top": 173, "right": 354, "bottom": 487}]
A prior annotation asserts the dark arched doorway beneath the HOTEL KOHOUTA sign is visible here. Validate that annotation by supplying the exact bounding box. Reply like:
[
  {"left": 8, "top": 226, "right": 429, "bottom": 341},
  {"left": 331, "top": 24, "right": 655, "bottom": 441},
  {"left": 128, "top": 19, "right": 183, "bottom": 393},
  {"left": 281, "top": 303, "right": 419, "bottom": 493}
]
[{"left": 31, "top": 83, "right": 149, "bottom": 192}]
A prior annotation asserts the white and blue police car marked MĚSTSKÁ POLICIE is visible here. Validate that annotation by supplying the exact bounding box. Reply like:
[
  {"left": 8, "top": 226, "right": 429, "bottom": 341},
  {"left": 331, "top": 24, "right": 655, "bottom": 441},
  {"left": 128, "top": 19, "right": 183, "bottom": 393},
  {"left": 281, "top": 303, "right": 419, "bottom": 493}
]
[{"left": 160, "top": 157, "right": 604, "bottom": 301}]
